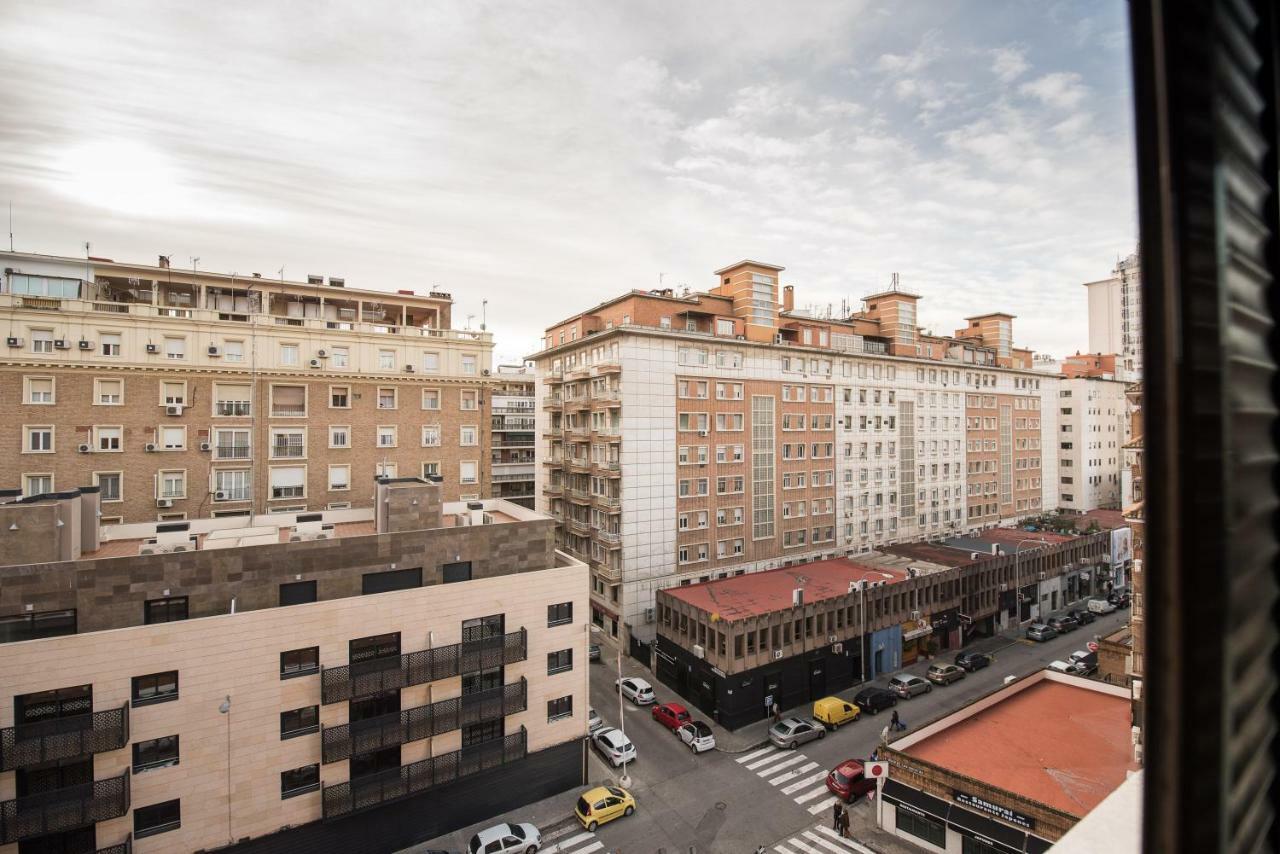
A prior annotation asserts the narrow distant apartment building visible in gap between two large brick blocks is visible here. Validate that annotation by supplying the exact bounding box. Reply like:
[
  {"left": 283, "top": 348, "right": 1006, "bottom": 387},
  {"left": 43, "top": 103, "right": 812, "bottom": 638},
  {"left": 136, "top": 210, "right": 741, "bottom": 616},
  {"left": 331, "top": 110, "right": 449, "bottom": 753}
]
[{"left": 489, "top": 365, "right": 538, "bottom": 508}]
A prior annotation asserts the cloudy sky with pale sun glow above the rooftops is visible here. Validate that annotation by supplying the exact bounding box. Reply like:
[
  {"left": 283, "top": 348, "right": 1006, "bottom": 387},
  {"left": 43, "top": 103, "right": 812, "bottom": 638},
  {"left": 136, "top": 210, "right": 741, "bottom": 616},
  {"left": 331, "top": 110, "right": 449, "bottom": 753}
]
[{"left": 0, "top": 0, "right": 1137, "bottom": 360}]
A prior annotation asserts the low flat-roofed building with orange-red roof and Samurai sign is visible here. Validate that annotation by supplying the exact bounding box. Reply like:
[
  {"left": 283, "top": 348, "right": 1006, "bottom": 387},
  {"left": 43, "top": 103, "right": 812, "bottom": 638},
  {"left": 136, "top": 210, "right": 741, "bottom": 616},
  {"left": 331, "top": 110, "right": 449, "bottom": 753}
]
[{"left": 878, "top": 670, "right": 1138, "bottom": 854}]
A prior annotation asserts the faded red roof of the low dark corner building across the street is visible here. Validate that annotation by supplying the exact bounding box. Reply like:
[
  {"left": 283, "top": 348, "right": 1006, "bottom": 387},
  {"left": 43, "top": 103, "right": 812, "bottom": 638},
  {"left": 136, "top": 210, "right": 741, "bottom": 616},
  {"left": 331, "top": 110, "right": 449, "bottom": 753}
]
[{"left": 662, "top": 557, "right": 908, "bottom": 620}]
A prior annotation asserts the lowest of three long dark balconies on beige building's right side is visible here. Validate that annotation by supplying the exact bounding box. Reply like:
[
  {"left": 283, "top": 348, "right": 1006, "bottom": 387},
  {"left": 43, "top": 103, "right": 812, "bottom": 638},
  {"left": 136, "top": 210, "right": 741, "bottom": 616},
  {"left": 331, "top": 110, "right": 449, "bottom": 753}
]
[{"left": 321, "top": 727, "right": 527, "bottom": 821}]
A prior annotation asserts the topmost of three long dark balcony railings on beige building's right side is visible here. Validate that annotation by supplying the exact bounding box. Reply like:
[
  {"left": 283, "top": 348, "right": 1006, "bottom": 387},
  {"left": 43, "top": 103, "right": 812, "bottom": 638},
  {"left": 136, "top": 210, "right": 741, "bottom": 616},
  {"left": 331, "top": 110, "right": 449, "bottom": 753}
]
[{"left": 320, "top": 629, "right": 529, "bottom": 705}]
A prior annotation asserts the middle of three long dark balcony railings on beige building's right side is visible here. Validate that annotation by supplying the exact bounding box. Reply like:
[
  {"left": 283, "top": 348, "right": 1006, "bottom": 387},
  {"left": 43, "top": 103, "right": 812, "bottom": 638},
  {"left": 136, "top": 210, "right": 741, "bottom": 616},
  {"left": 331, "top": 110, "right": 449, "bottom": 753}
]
[{"left": 320, "top": 677, "right": 529, "bottom": 764}]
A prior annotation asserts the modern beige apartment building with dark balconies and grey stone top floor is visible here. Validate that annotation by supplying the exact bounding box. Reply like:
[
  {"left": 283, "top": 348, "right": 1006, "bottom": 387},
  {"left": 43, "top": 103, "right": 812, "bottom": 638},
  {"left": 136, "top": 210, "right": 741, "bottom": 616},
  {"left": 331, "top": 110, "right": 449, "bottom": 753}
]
[{"left": 0, "top": 479, "right": 589, "bottom": 854}]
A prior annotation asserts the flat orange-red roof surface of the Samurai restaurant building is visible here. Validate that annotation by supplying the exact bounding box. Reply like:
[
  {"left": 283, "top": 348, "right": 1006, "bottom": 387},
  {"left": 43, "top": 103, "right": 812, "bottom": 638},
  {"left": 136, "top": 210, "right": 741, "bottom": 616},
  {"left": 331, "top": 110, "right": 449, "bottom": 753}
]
[{"left": 902, "top": 680, "right": 1138, "bottom": 816}]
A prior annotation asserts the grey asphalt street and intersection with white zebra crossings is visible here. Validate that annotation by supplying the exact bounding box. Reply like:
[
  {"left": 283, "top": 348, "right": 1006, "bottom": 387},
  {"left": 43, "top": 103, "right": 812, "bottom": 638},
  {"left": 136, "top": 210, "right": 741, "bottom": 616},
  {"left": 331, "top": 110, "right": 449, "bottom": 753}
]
[{"left": 581, "top": 611, "right": 1128, "bottom": 854}]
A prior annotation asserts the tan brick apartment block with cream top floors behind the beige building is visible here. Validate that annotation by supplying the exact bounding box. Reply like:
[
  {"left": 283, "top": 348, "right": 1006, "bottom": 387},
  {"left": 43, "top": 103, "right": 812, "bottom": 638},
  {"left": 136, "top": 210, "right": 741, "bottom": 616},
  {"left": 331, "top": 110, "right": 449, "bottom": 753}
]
[{"left": 0, "top": 252, "right": 493, "bottom": 522}]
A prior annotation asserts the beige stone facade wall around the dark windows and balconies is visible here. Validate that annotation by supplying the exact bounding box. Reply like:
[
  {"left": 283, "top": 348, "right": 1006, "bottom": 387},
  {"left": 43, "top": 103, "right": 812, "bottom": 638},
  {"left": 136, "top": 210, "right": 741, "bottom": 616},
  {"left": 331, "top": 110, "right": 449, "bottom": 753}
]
[{"left": 0, "top": 565, "right": 589, "bottom": 854}]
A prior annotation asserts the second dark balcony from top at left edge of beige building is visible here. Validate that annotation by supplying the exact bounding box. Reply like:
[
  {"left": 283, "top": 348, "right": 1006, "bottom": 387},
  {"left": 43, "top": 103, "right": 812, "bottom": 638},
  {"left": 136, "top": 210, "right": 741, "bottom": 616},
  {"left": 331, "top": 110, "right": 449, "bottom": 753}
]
[{"left": 0, "top": 771, "right": 129, "bottom": 845}]
